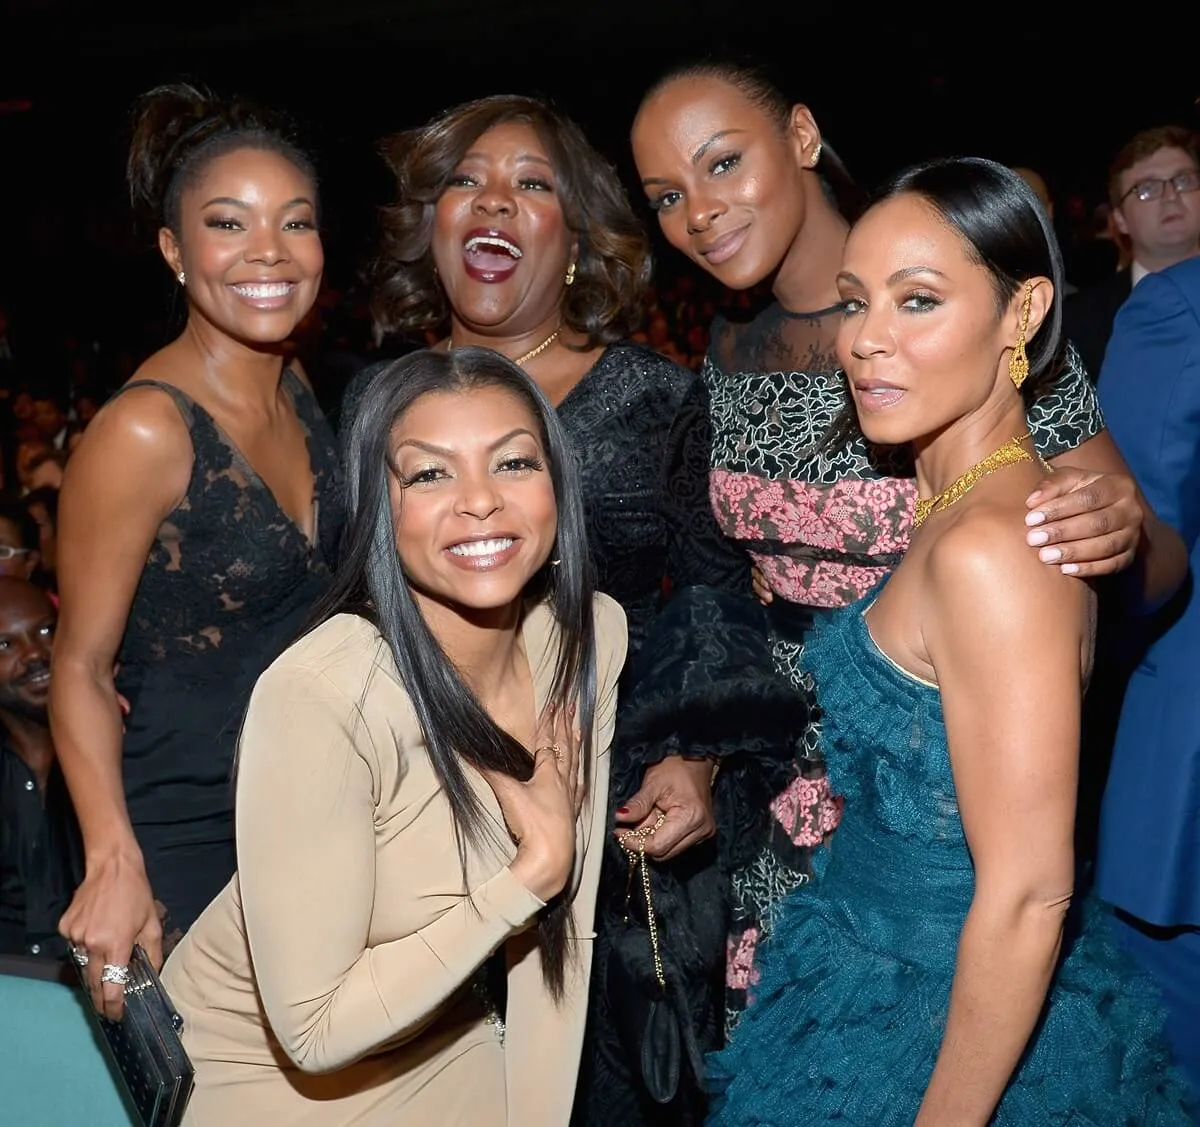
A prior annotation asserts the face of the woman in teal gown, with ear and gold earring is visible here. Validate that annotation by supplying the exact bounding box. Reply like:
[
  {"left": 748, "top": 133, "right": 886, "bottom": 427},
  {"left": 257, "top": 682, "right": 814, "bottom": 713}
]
[{"left": 838, "top": 193, "right": 1049, "bottom": 444}]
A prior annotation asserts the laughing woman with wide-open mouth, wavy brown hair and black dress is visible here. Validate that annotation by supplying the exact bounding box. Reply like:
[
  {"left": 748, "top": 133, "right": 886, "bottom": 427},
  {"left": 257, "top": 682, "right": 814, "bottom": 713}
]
[{"left": 343, "top": 95, "right": 756, "bottom": 1122}]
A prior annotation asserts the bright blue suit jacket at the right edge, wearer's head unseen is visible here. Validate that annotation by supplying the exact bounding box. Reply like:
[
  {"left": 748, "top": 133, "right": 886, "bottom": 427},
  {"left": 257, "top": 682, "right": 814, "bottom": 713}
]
[{"left": 1097, "top": 258, "right": 1200, "bottom": 927}]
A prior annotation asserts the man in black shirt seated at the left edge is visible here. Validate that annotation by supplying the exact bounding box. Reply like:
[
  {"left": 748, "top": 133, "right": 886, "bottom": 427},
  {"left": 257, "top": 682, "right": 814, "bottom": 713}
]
[{"left": 0, "top": 576, "right": 79, "bottom": 958}]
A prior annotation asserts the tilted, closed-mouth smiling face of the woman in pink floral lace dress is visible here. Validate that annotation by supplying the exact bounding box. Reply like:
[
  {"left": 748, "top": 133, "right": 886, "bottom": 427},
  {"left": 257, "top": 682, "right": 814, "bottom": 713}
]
[{"left": 631, "top": 77, "right": 817, "bottom": 289}]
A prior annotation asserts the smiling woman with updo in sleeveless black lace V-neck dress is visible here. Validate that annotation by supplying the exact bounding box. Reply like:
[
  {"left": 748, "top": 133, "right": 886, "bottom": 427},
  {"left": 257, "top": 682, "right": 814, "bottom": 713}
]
[{"left": 50, "top": 85, "right": 343, "bottom": 1017}]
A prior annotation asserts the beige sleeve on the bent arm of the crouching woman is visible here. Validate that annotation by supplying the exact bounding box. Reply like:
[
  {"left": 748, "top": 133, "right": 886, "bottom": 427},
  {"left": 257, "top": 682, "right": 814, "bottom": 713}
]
[{"left": 238, "top": 666, "right": 542, "bottom": 1072}]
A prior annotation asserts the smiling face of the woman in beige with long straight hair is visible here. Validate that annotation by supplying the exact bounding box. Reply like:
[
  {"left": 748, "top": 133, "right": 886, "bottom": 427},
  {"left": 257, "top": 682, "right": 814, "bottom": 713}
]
[{"left": 390, "top": 388, "right": 558, "bottom": 617}]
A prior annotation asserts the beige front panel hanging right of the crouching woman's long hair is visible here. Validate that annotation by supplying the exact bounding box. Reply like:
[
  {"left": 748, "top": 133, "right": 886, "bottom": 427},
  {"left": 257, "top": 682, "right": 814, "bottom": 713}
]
[{"left": 505, "top": 595, "right": 628, "bottom": 1127}]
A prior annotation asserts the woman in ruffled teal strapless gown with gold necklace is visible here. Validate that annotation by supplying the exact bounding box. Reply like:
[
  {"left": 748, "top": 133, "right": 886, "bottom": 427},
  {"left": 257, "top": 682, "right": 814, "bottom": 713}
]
[{"left": 709, "top": 160, "right": 1192, "bottom": 1127}]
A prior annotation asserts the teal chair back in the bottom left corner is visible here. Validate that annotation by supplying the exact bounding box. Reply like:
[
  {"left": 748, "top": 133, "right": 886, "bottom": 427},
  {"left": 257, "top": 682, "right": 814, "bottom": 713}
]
[{"left": 0, "top": 957, "right": 139, "bottom": 1127}]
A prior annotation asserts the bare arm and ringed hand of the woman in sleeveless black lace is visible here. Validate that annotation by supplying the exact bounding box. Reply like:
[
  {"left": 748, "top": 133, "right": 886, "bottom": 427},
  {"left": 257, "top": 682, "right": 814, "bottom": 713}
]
[{"left": 50, "top": 389, "right": 192, "bottom": 1015}]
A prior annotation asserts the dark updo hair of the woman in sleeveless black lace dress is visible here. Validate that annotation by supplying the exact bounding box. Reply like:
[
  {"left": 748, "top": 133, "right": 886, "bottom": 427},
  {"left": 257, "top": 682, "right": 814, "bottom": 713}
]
[{"left": 125, "top": 83, "right": 317, "bottom": 230}]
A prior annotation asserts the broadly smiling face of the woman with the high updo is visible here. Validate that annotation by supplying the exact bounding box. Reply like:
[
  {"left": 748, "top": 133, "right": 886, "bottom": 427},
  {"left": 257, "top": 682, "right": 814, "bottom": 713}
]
[{"left": 158, "top": 149, "right": 324, "bottom": 347}]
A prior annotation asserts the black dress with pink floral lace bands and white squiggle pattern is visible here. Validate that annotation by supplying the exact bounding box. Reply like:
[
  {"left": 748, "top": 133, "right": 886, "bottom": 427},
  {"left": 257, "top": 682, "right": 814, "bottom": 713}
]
[{"left": 702, "top": 305, "right": 1104, "bottom": 1030}]
